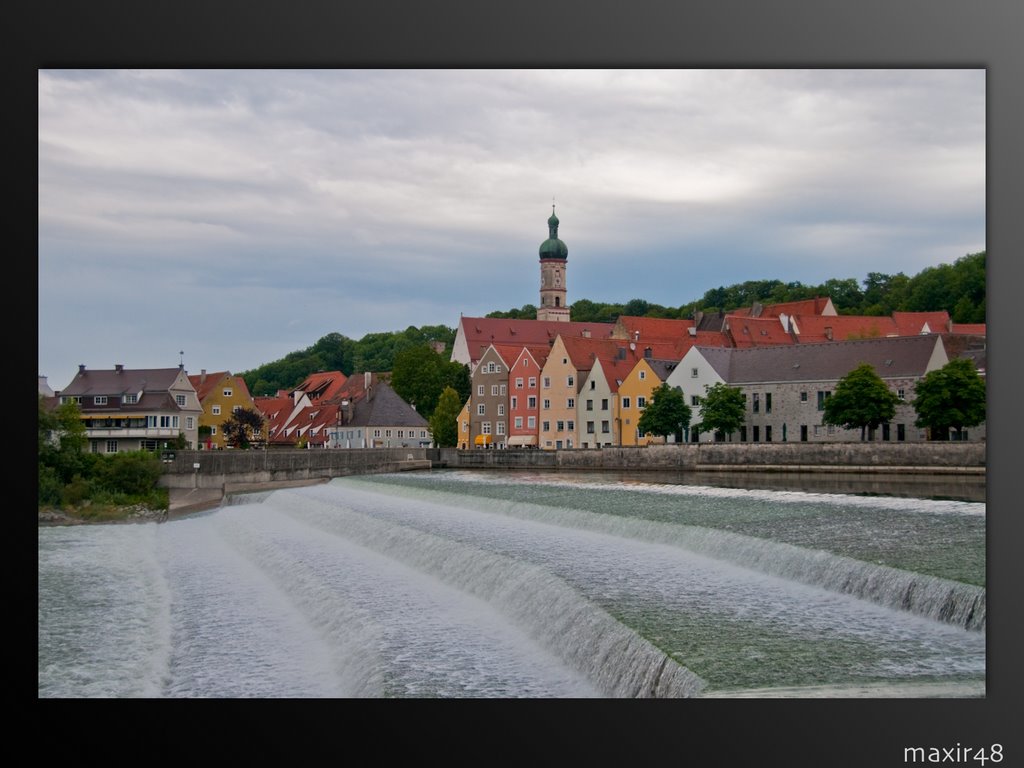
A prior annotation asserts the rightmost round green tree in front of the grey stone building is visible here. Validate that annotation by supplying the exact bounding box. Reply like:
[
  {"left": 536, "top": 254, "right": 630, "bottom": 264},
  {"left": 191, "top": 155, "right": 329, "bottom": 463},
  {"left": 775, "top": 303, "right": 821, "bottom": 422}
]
[{"left": 912, "top": 357, "right": 985, "bottom": 440}]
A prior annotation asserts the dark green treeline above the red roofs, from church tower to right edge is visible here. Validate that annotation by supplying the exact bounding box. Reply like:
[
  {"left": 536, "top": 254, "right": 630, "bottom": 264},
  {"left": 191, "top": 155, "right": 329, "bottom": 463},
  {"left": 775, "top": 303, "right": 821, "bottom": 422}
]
[{"left": 487, "top": 251, "right": 986, "bottom": 323}]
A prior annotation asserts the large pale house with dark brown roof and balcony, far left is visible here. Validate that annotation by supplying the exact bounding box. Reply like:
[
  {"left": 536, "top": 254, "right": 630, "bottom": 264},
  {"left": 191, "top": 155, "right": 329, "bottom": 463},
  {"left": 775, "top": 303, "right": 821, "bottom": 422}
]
[{"left": 55, "top": 365, "right": 203, "bottom": 454}]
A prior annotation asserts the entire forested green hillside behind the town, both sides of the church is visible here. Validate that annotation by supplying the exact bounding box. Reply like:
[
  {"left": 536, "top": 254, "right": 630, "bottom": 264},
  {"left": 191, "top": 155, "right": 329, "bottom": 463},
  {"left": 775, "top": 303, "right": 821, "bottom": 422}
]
[{"left": 239, "top": 251, "right": 986, "bottom": 395}]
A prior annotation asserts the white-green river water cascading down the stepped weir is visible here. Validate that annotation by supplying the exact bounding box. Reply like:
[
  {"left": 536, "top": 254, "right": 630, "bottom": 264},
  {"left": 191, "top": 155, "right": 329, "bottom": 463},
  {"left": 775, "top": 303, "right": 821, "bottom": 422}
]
[{"left": 39, "top": 472, "right": 985, "bottom": 697}]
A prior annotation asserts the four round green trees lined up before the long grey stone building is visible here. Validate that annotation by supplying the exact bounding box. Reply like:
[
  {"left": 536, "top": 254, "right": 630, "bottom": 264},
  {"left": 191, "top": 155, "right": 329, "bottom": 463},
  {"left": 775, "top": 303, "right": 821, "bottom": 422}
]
[{"left": 637, "top": 358, "right": 985, "bottom": 440}]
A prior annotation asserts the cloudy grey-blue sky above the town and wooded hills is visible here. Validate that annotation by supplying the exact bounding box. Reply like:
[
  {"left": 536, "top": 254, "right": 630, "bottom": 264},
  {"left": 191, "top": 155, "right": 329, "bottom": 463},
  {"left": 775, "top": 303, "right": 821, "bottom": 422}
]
[{"left": 38, "top": 69, "right": 986, "bottom": 389}]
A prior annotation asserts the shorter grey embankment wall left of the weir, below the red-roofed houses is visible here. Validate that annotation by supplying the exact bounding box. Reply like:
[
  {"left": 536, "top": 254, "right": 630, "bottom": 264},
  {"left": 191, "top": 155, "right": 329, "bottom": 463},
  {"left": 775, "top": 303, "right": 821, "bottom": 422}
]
[{"left": 160, "top": 449, "right": 431, "bottom": 489}]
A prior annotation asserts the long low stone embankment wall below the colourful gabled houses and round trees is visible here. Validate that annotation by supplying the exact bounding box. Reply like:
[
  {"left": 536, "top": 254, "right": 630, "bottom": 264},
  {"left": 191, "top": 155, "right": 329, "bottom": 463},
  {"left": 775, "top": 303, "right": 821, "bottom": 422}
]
[{"left": 436, "top": 442, "right": 985, "bottom": 474}]
